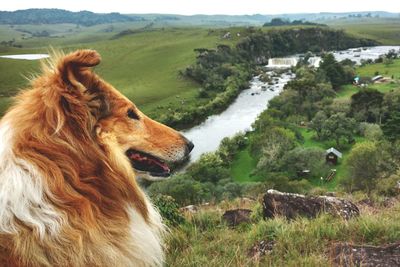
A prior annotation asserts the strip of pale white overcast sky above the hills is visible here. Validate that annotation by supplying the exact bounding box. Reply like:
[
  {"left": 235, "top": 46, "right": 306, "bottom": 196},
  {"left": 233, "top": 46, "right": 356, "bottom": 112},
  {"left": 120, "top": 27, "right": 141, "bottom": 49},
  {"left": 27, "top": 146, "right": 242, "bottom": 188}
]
[{"left": 0, "top": 0, "right": 400, "bottom": 15}]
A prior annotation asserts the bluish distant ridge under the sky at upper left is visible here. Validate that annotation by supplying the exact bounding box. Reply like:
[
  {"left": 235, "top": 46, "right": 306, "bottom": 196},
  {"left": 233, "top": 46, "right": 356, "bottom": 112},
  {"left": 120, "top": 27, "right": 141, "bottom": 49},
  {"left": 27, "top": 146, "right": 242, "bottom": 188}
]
[{"left": 0, "top": 9, "right": 144, "bottom": 26}]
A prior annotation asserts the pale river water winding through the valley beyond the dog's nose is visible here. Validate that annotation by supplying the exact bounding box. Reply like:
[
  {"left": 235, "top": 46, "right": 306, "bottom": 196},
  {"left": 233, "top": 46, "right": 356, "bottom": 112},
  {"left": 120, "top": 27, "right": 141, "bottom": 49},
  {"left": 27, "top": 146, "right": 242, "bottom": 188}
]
[{"left": 182, "top": 46, "right": 400, "bottom": 162}]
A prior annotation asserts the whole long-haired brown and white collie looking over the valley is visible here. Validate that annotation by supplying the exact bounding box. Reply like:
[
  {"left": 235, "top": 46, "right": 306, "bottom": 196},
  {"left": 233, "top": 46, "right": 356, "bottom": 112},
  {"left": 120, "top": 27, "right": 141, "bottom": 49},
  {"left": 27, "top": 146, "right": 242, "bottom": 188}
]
[{"left": 0, "top": 50, "right": 193, "bottom": 267}]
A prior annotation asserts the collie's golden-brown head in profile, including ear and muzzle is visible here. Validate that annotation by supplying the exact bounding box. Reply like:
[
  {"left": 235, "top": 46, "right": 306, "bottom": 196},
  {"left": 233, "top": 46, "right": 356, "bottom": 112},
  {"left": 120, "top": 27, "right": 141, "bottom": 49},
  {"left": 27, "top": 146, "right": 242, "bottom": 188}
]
[{"left": 47, "top": 50, "right": 193, "bottom": 180}]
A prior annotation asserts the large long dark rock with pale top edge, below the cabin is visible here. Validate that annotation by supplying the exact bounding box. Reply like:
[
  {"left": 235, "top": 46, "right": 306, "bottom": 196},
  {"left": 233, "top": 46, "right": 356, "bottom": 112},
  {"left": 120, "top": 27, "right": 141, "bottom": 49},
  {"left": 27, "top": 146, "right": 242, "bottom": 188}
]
[{"left": 262, "top": 189, "right": 360, "bottom": 220}]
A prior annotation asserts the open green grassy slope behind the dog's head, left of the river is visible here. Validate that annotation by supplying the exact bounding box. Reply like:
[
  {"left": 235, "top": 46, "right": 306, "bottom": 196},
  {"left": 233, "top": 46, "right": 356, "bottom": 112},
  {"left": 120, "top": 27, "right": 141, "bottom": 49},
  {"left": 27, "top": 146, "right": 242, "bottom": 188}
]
[{"left": 0, "top": 29, "right": 237, "bottom": 116}]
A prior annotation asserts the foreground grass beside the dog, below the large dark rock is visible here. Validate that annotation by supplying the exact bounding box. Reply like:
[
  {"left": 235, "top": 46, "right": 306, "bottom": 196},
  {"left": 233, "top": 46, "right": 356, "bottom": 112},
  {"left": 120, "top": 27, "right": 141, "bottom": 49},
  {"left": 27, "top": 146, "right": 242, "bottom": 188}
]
[{"left": 167, "top": 202, "right": 400, "bottom": 267}]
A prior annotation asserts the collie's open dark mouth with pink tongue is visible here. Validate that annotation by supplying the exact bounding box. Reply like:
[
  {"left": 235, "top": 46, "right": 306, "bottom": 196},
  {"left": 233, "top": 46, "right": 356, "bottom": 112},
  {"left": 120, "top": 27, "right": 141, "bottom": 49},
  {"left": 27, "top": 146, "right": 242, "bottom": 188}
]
[{"left": 126, "top": 149, "right": 171, "bottom": 178}]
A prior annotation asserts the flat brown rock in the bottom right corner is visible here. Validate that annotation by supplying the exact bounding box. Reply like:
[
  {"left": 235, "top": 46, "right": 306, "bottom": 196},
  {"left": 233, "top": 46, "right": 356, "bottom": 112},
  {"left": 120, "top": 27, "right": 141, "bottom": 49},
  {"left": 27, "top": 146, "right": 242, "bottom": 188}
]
[{"left": 332, "top": 242, "right": 400, "bottom": 267}]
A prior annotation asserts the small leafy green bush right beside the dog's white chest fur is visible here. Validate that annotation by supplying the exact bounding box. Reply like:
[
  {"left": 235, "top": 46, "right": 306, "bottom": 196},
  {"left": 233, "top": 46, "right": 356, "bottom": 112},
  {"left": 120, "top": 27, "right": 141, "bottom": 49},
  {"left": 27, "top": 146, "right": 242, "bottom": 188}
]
[{"left": 152, "top": 195, "right": 185, "bottom": 226}]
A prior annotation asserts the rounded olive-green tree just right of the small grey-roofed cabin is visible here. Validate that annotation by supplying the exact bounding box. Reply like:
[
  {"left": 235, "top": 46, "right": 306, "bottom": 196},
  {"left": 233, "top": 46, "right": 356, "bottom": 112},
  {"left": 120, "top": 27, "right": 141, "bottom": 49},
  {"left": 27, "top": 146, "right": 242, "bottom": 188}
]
[{"left": 347, "top": 141, "right": 379, "bottom": 193}]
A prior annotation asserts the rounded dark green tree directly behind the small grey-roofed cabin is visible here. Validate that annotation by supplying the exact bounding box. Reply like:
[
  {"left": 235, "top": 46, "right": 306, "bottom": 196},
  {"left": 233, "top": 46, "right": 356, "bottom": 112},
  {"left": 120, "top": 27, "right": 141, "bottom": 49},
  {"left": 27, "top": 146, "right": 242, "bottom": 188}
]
[{"left": 321, "top": 113, "right": 356, "bottom": 147}]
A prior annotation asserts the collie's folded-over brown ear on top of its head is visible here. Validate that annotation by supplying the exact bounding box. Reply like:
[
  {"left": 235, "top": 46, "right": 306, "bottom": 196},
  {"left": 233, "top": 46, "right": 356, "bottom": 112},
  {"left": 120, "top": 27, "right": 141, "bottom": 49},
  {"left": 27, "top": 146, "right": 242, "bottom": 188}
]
[{"left": 57, "top": 50, "right": 101, "bottom": 94}]
